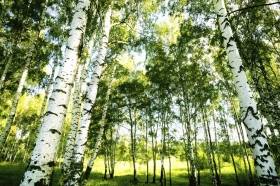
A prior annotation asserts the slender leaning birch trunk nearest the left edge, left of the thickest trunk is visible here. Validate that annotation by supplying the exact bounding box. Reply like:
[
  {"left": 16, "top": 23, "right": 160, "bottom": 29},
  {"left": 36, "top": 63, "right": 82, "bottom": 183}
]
[{"left": 0, "top": 0, "right": 48, "bottom": 149}]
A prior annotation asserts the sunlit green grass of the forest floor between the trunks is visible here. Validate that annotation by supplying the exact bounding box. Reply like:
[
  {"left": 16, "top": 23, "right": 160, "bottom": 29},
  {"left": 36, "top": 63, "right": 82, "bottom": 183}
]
[{"left": 0, "top": 160, "right": 252, "bottom": 186}]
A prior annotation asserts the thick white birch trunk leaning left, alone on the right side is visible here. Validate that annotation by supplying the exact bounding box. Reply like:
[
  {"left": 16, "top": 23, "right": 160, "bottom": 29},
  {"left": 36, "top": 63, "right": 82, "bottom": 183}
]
[{"left": 213, "top": 0, "right": 279, "bottom": 185}]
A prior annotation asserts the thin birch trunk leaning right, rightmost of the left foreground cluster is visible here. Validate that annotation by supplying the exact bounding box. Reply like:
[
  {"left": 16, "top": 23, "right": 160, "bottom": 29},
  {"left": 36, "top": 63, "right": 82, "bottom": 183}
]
[{"left": 83, "top": 65, "right": 116, "bottom": 185}]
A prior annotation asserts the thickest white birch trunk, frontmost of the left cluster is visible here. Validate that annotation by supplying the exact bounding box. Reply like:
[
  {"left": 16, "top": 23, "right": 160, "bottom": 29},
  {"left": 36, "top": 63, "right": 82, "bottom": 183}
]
[{"left": 21, "top": 0, "right": 90, "bottom": 186}]
